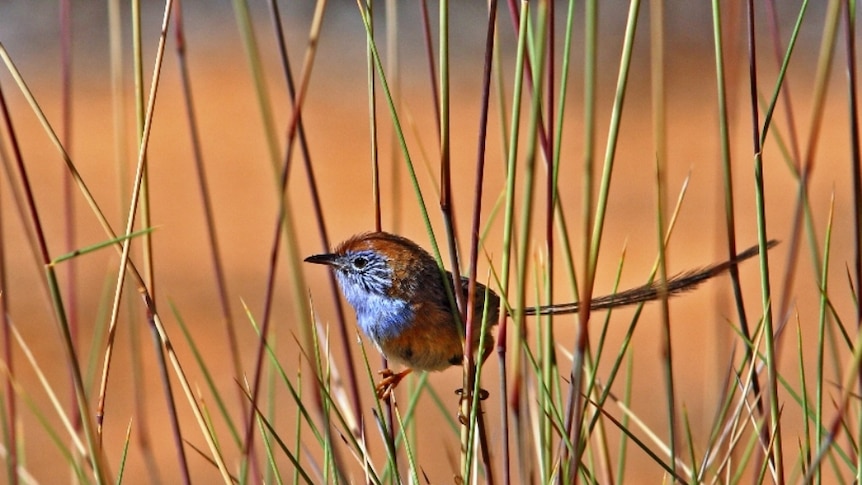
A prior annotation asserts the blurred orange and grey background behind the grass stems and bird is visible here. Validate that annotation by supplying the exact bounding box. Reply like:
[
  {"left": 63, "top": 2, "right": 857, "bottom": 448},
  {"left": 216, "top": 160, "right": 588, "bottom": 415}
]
[{"left": 0, "top": 0, "right": 854, "bottom": 483}]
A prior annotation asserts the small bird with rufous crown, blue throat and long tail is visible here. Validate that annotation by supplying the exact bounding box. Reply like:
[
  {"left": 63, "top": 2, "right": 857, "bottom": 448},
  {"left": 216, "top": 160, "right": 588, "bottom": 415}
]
[{"left": 305, "top": 232, "right": 777, "bottom": 399}]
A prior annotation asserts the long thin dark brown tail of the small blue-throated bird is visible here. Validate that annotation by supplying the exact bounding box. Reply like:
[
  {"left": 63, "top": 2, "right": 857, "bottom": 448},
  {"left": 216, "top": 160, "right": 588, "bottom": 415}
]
[{"left": 524, "top": 239, "right": 778, "bottom": 315}]
